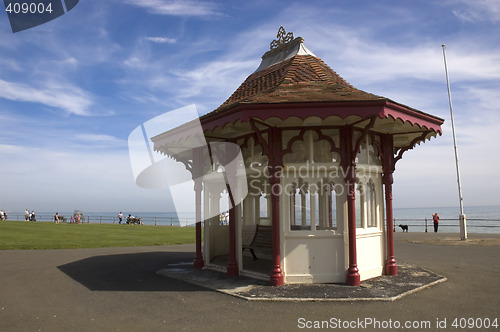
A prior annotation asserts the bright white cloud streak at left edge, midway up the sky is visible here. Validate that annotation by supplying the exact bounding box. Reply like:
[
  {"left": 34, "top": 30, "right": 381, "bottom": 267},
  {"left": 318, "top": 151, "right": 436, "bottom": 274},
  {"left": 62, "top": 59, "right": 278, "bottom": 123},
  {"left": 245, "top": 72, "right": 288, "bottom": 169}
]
[{"left": 0, "top": 79, "right": 93, "bottom": 115}]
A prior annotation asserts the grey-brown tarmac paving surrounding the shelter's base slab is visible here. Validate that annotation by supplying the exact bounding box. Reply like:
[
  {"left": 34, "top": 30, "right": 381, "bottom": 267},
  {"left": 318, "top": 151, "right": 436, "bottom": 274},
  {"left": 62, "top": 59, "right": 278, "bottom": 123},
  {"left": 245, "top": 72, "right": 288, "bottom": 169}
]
[{"left": 0, "top": 233, "right": 500, "bottom": 332}]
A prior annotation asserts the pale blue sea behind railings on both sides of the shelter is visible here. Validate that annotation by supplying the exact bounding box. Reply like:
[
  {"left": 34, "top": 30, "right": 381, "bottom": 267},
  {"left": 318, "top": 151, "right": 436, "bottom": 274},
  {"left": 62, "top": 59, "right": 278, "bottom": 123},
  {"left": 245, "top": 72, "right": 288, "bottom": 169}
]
[{"left": 4, "top": 206, "right": 500, "bottom": 234}]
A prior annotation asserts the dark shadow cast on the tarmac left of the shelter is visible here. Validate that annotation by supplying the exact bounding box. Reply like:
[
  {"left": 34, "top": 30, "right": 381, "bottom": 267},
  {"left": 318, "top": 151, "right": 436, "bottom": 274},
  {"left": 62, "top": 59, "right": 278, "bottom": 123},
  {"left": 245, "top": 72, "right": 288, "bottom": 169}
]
[{"left": 58, "top": 252, "right": 206, "bottom": 292}]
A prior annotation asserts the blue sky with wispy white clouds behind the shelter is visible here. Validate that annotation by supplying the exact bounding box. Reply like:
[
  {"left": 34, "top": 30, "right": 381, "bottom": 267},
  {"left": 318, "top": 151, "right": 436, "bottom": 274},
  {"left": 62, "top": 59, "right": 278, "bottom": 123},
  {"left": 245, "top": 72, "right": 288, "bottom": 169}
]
[{"left": 0, "top": 0, "right": 500, "bottom": 212}]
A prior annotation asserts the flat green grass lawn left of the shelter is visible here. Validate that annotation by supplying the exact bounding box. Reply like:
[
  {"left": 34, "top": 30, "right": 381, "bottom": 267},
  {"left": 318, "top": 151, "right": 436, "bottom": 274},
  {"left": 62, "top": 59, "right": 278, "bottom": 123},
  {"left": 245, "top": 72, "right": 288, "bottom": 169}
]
[{"left": 0, "top": 221, "right": 195, "bottom": 250}]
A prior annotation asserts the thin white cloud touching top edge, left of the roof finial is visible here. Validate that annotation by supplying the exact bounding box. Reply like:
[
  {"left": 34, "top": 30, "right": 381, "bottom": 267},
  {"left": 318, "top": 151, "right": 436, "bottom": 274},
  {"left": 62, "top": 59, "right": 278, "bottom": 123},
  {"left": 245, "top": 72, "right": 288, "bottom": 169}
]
[{"left": 124, "top": 0, "right": 221, "bottom": 16}]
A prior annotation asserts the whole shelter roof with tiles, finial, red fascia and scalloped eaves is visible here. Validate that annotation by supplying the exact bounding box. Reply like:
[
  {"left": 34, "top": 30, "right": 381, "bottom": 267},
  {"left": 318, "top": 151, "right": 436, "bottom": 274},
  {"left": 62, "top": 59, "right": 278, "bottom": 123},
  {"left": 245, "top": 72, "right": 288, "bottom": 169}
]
[{"left": 153, "top": 27, "right": 444, "bottom": 154}]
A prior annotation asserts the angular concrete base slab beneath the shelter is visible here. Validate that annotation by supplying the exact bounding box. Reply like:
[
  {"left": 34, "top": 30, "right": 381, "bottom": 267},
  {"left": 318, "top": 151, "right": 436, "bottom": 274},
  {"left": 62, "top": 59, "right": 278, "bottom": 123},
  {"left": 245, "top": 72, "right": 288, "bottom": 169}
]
[{"left": 157, "top": 263, "right": 446, "bottom": 301}]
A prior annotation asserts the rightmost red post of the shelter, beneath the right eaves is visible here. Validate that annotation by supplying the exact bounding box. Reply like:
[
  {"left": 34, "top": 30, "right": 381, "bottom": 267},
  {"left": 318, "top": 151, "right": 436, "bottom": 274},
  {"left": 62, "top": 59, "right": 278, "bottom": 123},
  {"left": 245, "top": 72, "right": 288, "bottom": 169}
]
[{"left": 382, "top": 135, "right": 398, "bottom": 276}]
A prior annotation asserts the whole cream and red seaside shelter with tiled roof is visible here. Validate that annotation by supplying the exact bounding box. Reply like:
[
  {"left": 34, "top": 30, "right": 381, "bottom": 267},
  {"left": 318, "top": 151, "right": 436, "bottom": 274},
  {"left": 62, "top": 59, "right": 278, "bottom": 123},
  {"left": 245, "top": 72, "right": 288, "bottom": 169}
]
[{"left": 152, "top": 27, "right": 443, "bottom": 286}]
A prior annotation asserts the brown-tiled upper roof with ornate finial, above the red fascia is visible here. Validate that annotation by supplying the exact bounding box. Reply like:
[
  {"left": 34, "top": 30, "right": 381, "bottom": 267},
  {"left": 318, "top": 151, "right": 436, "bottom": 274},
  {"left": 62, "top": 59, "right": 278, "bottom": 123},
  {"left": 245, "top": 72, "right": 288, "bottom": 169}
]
[{"left": 201, "top": 32, "right": 443, "bottom": 128}]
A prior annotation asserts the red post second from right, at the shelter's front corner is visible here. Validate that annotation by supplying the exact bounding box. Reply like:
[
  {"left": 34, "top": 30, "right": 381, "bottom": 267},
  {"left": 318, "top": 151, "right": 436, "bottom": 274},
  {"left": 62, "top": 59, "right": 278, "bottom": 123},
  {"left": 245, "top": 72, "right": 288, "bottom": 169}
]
[{"left": 341, "top": 127, "right": 361, "bottom": 286}]
